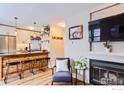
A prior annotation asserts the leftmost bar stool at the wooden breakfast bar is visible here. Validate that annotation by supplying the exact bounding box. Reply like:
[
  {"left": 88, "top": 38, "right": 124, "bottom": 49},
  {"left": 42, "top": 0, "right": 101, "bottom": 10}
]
[{"left": 4, "top": 60, "right": 22, "bottom": 84}]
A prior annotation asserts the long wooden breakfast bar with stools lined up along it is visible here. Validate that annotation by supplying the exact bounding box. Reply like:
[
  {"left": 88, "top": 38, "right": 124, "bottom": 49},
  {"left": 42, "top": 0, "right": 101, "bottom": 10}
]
[{"left": 0, "top": 51, "right": 49, "bottom": 80}]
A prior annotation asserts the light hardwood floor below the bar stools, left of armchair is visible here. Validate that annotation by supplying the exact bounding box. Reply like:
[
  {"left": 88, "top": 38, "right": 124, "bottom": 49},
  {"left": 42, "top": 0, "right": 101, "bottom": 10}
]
[{"left": 0, "top": 69, "right": 52, "bottom": 85}]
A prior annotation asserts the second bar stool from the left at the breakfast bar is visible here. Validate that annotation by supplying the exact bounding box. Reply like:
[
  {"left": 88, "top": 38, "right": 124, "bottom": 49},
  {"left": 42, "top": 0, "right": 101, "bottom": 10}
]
[{"left": 21, "top": 58, "right": 35, "bottom": 78}]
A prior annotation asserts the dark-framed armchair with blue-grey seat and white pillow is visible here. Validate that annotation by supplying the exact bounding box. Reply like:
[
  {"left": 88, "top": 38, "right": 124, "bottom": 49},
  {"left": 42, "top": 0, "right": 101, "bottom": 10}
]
[{"left": 52, "top": 58, "right": 73, "bottom": 85}]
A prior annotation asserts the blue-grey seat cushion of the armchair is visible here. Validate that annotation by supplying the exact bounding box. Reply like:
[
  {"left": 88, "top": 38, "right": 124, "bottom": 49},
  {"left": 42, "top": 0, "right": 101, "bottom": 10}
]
[{"left": 52, "top": 71, "right": 72, "bottom": 82}]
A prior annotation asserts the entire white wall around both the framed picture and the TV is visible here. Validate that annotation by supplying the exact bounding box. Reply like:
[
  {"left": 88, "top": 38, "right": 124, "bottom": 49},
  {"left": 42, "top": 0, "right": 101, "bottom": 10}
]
[{"left": 64, "top": 4, "right": 124, "bottom": 82}]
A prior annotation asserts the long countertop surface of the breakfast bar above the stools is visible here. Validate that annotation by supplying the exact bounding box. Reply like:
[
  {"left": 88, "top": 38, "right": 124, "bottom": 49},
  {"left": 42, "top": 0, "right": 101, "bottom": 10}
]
[{"left": 0, "top": 51, "right": 49, "bottom": 57}]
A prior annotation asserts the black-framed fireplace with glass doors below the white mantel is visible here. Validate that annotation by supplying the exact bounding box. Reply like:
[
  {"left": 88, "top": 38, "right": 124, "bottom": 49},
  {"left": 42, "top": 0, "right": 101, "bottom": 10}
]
[{"left": 90, "top": 59, "right": 124, "bottom": 85}]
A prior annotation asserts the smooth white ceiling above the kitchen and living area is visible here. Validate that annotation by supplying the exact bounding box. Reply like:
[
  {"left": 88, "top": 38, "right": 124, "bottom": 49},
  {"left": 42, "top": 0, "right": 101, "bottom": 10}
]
[{"left": 0, "top": 3, "right": 102, "bottom": 26}]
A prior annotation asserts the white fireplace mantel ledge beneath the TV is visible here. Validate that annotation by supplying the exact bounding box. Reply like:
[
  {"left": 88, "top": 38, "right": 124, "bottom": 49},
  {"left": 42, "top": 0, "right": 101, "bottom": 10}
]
[{"left": 87, "top": 52, "right": 124, "bottom": 63}]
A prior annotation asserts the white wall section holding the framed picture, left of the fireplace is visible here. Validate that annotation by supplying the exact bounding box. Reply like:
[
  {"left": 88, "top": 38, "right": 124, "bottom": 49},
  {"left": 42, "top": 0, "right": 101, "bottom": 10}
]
[{"left": 64, "top": 13, "right": 89, "bottom": 82}]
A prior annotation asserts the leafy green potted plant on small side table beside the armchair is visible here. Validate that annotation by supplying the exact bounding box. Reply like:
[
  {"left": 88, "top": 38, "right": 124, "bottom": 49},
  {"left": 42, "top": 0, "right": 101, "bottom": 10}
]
[{"left": 74, "top": 58, "right": 86, "bottom": 69}]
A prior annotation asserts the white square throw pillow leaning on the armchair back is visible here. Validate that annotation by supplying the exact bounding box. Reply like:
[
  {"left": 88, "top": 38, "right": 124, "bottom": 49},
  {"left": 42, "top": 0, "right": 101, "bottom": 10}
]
[{"left": 56, "top": 59, "right": 69, "bottom": 72}]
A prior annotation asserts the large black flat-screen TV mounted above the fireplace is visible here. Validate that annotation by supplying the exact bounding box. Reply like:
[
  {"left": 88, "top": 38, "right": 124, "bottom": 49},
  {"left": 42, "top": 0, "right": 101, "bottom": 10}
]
[{"left": 89, "top": 13, "right": 124, "bottom": 42}]
